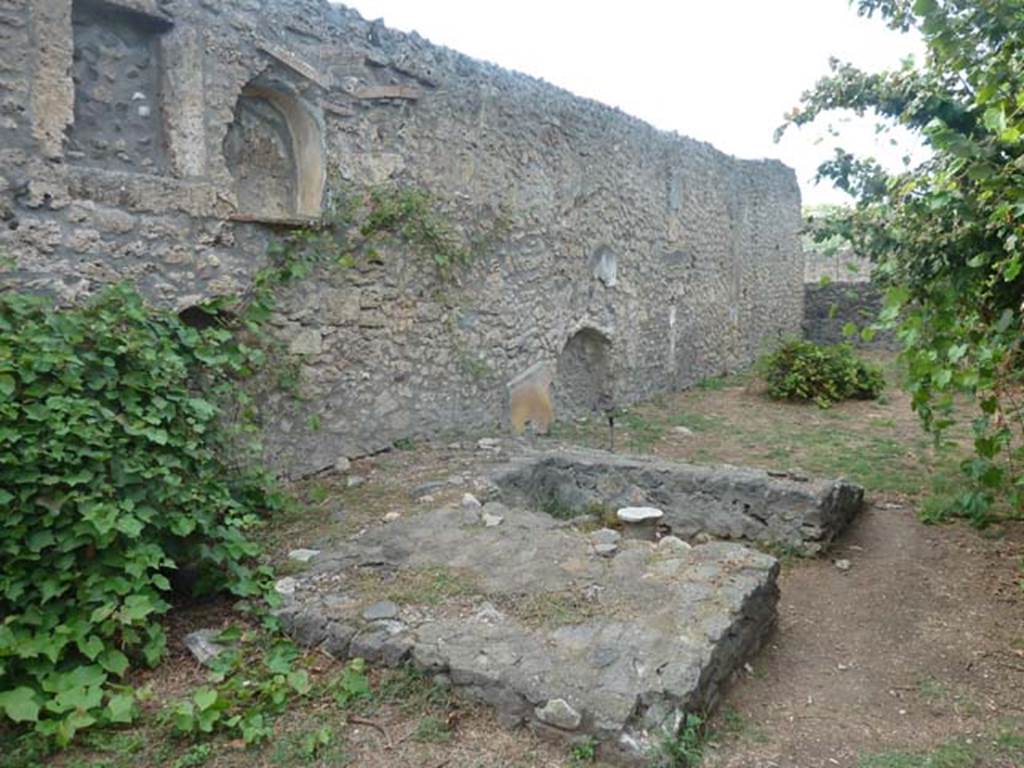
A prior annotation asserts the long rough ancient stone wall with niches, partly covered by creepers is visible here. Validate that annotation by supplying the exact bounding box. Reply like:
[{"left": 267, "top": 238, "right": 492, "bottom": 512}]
[{"left": 0, "top": 0, "right": 803, "bottom": 474}]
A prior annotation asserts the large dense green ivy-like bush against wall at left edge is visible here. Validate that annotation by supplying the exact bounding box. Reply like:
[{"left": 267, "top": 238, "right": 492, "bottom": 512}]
[{"left": 0, "top": 287, "right": 280, "bottom": 743}]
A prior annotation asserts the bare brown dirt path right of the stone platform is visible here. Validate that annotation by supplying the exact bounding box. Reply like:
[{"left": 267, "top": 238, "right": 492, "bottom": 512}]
[{"left": 707, "top": 506, "right": 1024, "bottom": 768}]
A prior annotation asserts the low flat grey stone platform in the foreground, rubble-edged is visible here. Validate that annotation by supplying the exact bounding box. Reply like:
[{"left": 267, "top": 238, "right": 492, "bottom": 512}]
[{"left": 281, "top": 503, "right": 778, "bottom": 765}]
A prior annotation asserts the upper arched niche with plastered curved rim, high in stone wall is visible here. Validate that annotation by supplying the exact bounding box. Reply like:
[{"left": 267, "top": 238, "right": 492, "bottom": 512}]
[{"left": 224, "top": 83, "right": 327, "bottom": 220}]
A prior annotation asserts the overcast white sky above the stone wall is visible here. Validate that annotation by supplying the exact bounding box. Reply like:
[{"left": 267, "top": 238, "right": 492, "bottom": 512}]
[{"left": 346, "top": 0, "right": 922, "bottom": 204}]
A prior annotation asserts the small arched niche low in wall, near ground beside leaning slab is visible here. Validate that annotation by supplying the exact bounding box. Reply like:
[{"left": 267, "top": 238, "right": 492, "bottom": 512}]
[{"left": 555, "top": 327, "right": 614, "bottom": 418}]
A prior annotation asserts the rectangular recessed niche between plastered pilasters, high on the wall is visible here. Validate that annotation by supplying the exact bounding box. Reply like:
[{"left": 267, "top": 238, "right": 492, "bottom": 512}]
[{"left": 67, "top": 0, "right": 170, "bottom": 173}]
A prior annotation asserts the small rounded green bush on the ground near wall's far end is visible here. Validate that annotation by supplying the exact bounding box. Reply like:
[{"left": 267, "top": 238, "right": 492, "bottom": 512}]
[{"left": 758, "top": 339, "right": 885, "bottom": 408}]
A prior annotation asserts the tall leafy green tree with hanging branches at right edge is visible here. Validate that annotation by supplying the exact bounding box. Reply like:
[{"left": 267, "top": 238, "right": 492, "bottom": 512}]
[{"left": 780, "top": 0, "right": 1024, "bottom": 525}]
